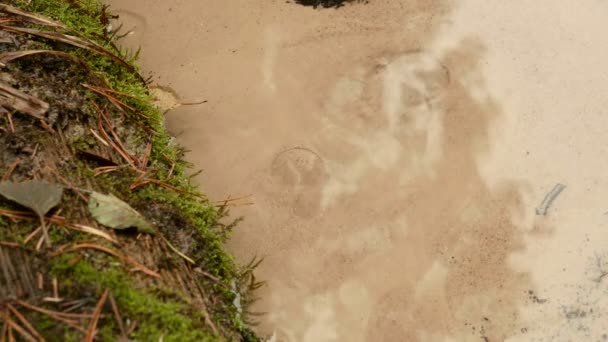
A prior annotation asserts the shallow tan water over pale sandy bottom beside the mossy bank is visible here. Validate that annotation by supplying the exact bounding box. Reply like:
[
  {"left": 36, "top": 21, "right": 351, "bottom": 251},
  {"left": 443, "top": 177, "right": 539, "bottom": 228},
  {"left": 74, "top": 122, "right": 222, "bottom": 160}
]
[{"left": 110, "top": 0, "right": 608, "bottom": 342}]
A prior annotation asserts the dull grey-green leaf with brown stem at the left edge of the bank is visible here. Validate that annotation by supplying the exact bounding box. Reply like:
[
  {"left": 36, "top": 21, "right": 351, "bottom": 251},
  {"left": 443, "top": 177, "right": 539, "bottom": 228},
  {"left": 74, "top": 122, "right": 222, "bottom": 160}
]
[{"left": 0, "top": 180, "right": 63, "bottom": 217}]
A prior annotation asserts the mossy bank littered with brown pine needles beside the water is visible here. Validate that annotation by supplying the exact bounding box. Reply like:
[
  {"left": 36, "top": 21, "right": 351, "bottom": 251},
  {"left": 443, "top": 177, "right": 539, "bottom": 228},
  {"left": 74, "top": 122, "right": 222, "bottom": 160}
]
[{"left": 0, "top": 0, "right": 259, "bottom": 341}]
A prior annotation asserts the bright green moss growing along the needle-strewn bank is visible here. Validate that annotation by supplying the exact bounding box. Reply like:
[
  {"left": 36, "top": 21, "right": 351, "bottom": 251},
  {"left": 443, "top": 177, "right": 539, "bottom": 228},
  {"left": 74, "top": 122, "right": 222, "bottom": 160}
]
[{"left": 0, "top": 0, "right": 259, "bottom": 341}]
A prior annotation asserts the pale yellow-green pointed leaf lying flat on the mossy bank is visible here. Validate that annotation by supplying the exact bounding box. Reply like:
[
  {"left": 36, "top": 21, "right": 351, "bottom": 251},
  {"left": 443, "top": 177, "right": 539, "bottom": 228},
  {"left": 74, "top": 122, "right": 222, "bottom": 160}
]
[{"left": 89, "top": 191, "right": 156, "bottom": 234}]
